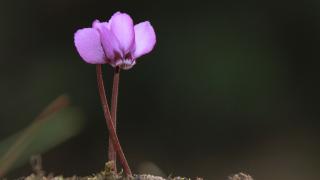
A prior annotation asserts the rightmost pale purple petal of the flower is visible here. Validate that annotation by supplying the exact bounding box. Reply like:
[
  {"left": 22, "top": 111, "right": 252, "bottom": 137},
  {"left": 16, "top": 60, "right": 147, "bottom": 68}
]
[{"left": 133, "top": 21, "right": 156, "bottom": 58}]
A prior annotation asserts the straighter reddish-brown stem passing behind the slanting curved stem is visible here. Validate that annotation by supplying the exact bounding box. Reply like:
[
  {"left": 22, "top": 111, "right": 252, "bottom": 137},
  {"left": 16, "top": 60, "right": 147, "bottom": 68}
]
[{"left": 108, "top": 67, "right": 120, "bottom": 172}]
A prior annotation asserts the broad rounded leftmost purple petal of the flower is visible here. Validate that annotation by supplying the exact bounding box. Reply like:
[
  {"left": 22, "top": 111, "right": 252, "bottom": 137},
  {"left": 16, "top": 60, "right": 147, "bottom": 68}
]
[{"left": 74, "top": 28, "right": 106, "bottom": 64}]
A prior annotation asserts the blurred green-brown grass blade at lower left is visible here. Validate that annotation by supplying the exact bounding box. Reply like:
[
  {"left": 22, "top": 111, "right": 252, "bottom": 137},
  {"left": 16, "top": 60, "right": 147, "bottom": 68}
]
[{"left": 0, "top": 96, "right": 84, "bottom": 177}]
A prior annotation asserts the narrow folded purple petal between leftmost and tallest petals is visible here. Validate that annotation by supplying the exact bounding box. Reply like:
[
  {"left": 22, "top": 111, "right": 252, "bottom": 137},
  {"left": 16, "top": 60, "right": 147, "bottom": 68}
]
[{"left": 93, "top": 20, "right": 121, "bottom": 60}]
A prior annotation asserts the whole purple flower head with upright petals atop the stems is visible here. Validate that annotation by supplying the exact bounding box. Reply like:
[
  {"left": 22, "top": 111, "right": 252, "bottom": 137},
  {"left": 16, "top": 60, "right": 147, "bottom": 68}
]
[{"left": 74, "top": 12, "right": 156, "bottom": 69}]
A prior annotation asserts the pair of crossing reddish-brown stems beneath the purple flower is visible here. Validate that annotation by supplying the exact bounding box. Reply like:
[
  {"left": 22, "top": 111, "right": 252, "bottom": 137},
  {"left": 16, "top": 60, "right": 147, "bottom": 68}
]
[{"left": 96, "top": 64, "right": 132, "bottom": 176}]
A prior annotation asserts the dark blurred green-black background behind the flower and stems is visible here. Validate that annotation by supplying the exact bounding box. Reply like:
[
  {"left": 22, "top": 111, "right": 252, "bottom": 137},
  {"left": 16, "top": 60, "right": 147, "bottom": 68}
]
[{"left": 0, "top": 0, "right": 320, "bottom": 180}]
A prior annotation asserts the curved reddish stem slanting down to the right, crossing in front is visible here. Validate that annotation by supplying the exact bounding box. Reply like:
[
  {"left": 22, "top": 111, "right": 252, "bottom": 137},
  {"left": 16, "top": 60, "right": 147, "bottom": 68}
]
[{"left": 96, "top": 64, "right": 132, "bottom": 176}]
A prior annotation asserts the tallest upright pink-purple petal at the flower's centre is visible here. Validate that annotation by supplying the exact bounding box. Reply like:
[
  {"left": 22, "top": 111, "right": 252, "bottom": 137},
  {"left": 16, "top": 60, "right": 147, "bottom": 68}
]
[{"left": 109, "top": 12, "right": 134, "bottom": 56}]
